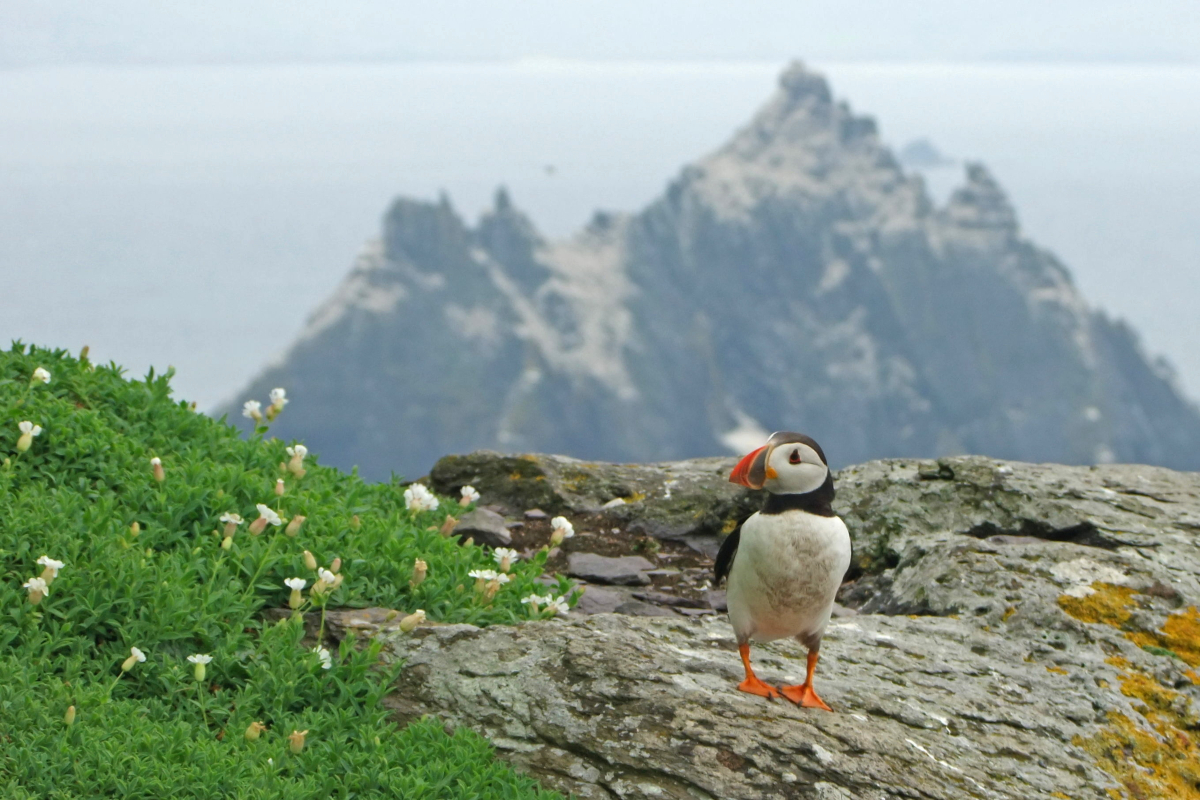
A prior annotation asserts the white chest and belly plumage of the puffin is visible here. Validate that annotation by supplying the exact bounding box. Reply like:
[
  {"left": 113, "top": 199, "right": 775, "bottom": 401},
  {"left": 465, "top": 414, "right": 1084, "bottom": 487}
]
[{"left": 728, "top": 511, "right": 850, "bottom": 639}]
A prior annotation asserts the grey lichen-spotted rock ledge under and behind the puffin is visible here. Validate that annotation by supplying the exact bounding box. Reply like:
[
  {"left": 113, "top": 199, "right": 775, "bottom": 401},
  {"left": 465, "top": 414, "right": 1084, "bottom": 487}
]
[{"left": 343, "top": 455, "right": 1200, "bottom": 800}]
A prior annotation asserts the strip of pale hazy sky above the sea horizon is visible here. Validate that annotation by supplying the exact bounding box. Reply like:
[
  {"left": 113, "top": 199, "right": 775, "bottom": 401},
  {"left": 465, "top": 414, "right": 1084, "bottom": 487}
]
[{"left": 7, "top": 0, "right": 1200, "bottom": 65}]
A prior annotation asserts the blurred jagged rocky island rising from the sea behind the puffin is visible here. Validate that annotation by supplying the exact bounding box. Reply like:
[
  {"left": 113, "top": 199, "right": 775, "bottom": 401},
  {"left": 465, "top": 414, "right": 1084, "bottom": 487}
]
[{"left": 218, "top": 65, "right": 1200, "bottom": 482}]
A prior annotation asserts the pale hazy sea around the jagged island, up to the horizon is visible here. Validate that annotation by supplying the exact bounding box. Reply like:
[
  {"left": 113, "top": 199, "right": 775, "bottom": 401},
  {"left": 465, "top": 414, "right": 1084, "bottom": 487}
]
[{"left": 0, "top": 61, "right": 1200, "bottom": 408}]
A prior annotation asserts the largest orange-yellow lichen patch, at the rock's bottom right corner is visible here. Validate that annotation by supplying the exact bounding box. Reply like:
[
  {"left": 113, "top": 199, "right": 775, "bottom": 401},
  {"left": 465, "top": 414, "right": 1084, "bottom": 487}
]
[{"left": 1073, "top": 657, "right": 1200, "bottom": 800}]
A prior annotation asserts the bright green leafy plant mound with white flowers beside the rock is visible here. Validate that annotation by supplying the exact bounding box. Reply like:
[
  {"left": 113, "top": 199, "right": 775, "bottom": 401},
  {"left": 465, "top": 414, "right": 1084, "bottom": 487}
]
[{"left": 0, "top": 344, "right": 565, "bottom": 800}]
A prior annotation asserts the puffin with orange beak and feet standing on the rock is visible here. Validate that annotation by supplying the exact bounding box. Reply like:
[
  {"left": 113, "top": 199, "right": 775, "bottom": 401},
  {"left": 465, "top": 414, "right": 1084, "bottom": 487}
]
[{"left": 715, "top": 431, "right": 850, "bottom": 711}]
